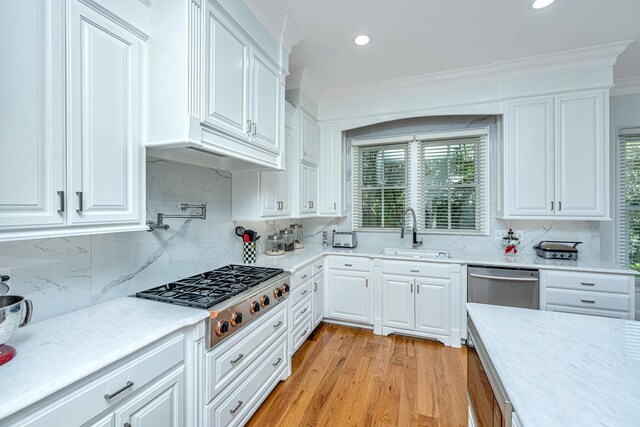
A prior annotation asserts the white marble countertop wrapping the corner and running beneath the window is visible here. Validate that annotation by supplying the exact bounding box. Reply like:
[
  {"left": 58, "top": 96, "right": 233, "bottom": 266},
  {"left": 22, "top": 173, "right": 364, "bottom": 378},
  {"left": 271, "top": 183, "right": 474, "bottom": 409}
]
[{"left": 256, "top": 244, "right": 636, "bottom": 274}]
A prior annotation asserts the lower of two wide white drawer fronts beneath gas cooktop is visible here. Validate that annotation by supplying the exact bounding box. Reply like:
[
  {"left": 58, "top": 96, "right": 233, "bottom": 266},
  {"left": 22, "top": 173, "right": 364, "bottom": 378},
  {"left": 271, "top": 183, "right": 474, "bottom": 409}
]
[{"left": 207, "top": 340, "right": 287, "bottom": 426}]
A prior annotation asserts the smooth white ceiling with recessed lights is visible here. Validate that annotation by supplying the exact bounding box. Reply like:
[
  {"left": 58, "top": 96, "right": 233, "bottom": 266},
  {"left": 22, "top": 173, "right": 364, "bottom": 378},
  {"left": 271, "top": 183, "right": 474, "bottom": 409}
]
[{"left": 277, "top": 0, "right": 640, "bottom": 89}]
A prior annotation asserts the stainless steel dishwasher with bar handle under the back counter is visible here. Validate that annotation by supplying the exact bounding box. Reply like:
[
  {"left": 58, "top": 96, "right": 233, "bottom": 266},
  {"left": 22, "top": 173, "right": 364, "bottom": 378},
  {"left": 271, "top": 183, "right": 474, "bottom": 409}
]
[{"left": 467, "top": 266, "right": 540, "bottom": 310}]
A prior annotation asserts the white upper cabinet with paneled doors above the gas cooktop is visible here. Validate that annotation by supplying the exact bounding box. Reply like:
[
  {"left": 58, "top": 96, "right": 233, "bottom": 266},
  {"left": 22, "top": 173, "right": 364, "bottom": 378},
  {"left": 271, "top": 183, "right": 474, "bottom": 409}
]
[{"left": 146, "top": 0, "right": 288, "bottom": 171}]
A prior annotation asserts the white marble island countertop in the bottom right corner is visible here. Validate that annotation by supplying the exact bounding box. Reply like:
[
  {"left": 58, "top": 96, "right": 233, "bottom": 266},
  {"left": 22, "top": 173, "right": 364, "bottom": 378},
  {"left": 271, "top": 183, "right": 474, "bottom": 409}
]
[{"left": 467, "top": 304, "right": 640, "bottom": 427}]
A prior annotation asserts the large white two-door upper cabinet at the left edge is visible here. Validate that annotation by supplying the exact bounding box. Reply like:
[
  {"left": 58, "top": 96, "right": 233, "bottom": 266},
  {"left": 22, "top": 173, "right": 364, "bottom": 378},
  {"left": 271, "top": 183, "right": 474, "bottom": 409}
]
[{"left": 0, "top": 0, "right": 149, "bottom": 240}]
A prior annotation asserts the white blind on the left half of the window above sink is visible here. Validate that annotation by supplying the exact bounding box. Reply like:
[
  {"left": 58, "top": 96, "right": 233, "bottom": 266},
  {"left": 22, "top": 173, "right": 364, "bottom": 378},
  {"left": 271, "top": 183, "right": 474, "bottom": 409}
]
[{"left": 353, "top": 143, "right": 409, "bottom": 230}]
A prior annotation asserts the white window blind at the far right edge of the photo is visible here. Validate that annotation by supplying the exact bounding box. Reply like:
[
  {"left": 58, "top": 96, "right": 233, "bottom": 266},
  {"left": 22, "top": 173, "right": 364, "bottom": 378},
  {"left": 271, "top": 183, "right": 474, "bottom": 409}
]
[{"left": 618, "top": 128, "right": 640, "bottom": 271}]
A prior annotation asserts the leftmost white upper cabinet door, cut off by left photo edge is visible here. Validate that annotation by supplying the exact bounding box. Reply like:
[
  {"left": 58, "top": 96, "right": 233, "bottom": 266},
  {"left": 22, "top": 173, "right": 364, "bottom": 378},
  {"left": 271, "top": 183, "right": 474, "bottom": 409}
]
[{"left": 0, "top": 0, "right": 65, "bottom": 229}]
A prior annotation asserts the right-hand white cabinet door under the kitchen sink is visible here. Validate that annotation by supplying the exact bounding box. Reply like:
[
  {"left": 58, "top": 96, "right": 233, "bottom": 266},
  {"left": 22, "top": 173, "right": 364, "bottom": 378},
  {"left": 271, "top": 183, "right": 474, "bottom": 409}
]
[{"left": 415, "top": 279, "right": 450, "bottom": 335}]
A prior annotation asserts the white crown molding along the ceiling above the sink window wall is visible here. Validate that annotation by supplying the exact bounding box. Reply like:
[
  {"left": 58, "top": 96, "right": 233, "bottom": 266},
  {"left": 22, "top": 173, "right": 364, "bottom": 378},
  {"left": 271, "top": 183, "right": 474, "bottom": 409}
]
[{"left": 320, "top": 40, "right": 632, "bottom": 104}]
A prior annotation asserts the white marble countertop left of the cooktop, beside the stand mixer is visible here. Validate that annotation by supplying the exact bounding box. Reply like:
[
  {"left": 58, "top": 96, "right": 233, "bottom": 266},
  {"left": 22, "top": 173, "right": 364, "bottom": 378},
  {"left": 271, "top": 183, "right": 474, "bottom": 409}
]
[{"left": 0, "top": 297, "right": 209, "bottom": 420}]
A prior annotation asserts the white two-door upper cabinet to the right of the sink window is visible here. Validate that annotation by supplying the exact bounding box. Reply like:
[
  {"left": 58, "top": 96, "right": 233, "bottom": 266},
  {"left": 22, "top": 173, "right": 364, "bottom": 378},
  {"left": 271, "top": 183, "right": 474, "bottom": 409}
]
[{"left": 500, "top": 90, "right": 609, "bottom": 220}]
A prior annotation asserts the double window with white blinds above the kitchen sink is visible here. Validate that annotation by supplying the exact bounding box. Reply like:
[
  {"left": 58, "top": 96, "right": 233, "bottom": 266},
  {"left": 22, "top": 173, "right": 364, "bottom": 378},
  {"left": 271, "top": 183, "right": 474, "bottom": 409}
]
[{"left": 353, "top": 129, "right": 488, "bottom": 234}]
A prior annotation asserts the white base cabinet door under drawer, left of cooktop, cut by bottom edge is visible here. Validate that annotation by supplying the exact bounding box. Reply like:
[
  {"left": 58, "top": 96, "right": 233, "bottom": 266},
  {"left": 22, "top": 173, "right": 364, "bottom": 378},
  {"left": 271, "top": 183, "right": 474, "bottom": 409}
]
[{"left": 116, "top": 367, "right": 185, "bottom": 427}]
